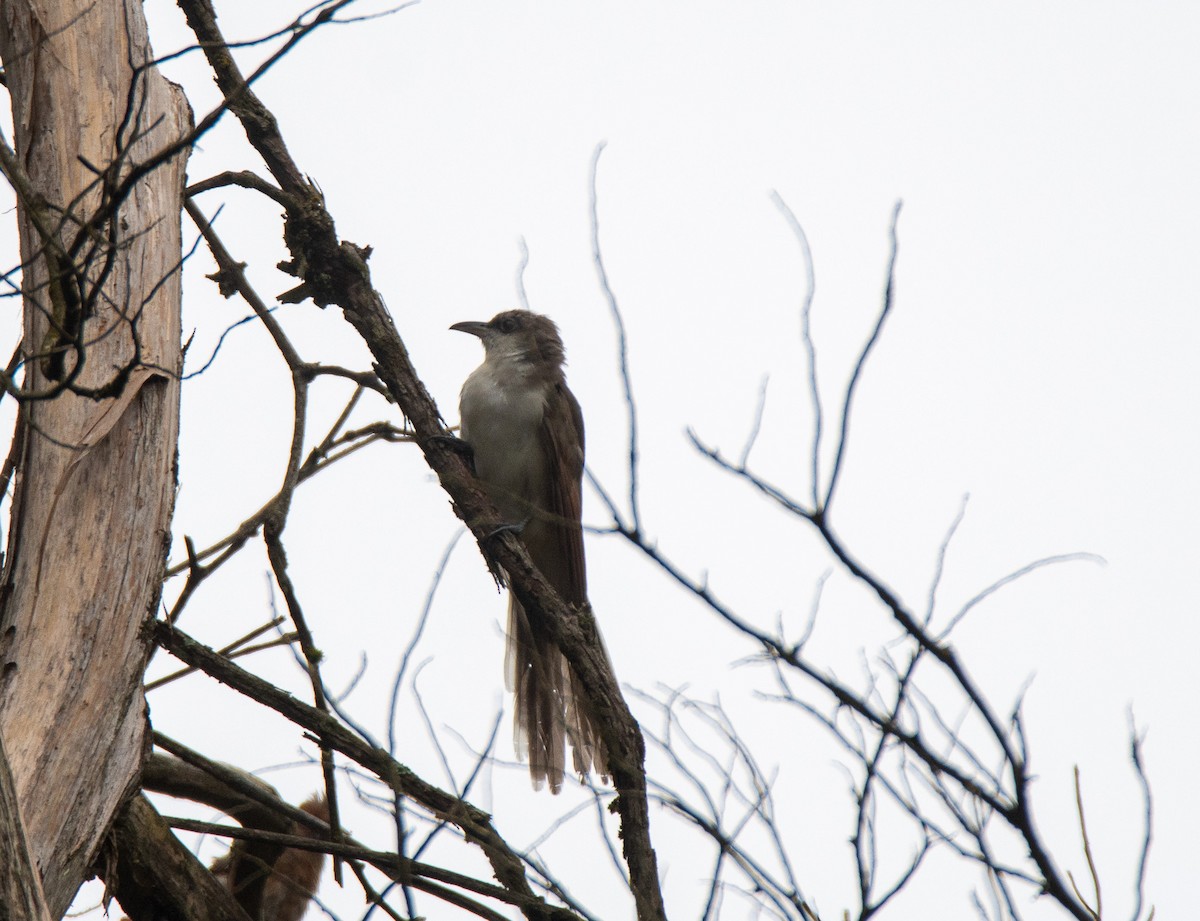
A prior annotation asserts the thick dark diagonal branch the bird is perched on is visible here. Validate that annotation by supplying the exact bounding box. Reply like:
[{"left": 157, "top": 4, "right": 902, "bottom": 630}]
[{"left": 180, "top": 0, "right": 665, "bottom": 921}]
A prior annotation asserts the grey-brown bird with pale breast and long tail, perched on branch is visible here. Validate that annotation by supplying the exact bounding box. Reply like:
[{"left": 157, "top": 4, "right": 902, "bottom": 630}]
[{"left": 450, "top": 311, "right": 607, "bottom": 793}]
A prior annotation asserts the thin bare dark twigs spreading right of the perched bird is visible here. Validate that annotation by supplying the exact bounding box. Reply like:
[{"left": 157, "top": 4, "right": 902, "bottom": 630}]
[{"left": 578, "top": 176, "right": 1153, "bottom": 921}]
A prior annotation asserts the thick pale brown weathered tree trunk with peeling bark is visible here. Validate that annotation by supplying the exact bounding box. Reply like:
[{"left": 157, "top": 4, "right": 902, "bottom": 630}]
[{"left": 0, "top": 0, "right": 190, "bottom": 917}]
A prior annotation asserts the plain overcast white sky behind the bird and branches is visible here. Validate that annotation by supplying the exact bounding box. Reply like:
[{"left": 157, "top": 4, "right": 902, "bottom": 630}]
[{"left": 18, "top": 0, "right": 1200, "bottom": 919}]
